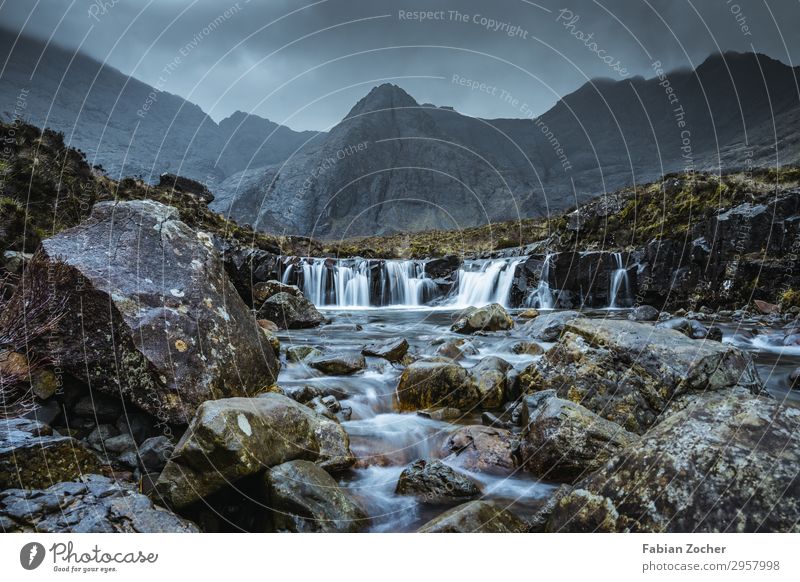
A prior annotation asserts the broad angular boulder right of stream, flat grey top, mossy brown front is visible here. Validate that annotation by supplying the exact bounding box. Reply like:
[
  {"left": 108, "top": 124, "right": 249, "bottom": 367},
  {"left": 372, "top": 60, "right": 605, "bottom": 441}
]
[{"left": 520, "top": 318, "right": 763, "bottom": 434}]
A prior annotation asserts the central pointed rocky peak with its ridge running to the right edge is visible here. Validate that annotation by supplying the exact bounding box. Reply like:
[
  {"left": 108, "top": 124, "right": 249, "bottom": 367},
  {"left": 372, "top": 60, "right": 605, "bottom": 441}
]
[{"left": 215, "top": 53, "right": 800, "bottom": 238}]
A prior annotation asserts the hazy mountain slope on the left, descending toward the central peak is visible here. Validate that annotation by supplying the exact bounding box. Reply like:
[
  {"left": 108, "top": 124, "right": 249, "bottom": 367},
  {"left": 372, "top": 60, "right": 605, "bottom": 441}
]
[{"left": 0, "top": 29, "right": 316, "bottom": 184}]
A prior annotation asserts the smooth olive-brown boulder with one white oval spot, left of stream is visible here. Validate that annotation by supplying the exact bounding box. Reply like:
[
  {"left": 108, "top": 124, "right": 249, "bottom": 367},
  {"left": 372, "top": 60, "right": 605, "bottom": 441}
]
[{"left": 156, "top": 393, "right": 355, "bottom": 507}]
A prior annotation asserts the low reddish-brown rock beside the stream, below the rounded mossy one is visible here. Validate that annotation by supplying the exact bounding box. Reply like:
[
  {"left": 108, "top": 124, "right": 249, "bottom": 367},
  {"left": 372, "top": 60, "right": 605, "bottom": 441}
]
[{"left": 445, "top": 426, "right": 519, "bottom": 475}]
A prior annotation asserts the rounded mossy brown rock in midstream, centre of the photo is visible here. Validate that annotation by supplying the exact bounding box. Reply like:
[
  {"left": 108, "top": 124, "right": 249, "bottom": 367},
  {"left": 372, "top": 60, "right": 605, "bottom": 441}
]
[{"left": 395, "top": 360, "right": 481, "bottom": 411}]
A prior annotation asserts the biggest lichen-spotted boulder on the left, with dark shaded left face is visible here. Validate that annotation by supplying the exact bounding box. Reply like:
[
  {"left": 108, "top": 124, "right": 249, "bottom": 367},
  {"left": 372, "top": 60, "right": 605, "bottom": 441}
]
[{"left": 15, "top": 200, "right": 279, "bottom": 424}]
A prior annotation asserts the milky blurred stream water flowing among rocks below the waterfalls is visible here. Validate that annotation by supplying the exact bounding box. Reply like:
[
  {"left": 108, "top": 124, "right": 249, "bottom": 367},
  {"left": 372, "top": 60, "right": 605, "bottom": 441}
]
[{"left": 279, "top": 296, "right": 800, "bottom": 531}]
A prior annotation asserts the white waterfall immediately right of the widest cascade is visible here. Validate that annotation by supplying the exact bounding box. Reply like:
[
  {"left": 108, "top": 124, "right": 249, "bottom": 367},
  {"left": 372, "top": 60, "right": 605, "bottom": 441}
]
[{"left": 452, "top": 258, "right": 524, "bottom": 307}]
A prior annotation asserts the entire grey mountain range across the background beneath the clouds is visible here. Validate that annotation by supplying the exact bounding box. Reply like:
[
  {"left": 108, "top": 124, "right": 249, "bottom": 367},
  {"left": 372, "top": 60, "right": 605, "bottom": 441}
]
[{"left": 0, "top": 32, "right": 800, "bottom": 238}]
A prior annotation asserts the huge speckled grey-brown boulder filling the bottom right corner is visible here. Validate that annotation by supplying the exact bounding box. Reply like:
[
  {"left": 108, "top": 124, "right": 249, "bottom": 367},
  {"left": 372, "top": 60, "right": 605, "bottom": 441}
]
[{"left": 548, "top": 389, "right": 800, "bottom": 532}]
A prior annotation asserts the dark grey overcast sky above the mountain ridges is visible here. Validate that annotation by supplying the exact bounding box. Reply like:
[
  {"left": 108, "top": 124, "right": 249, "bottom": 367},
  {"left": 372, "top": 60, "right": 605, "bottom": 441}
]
[{"left": 0, "top": 0, "right": 800, "bottom": 129}]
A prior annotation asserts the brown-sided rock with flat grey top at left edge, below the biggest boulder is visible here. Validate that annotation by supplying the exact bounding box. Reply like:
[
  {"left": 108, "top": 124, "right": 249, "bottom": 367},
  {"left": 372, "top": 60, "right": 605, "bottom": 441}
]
[{"left": 0, "top": 418, "right": 100, "bottom": 490}]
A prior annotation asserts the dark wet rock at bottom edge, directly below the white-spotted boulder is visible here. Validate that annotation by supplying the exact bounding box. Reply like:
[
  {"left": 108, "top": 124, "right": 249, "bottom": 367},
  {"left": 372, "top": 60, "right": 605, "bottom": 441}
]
[{"left": 265, "top": 460, "right": 369, "bottom": 533}]
